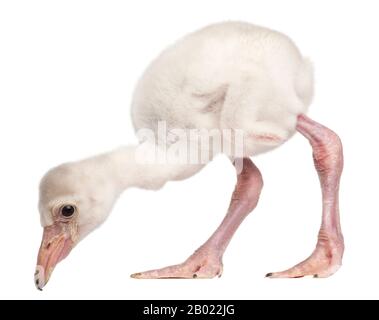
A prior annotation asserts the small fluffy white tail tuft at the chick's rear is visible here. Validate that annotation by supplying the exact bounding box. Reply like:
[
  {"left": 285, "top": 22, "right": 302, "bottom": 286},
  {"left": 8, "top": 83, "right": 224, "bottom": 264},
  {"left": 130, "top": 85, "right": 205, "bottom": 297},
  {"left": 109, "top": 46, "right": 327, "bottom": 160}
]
[{"left": 295, "top": 58, "right": 314, "bottom": 107}]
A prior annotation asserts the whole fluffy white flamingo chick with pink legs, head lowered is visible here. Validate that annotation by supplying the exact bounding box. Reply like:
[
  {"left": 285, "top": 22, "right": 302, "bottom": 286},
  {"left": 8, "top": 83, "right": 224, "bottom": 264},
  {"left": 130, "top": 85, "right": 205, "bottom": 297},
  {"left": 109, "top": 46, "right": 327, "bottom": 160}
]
[{"left": 35, "top": 22, "right": 344, "bottom": 289}]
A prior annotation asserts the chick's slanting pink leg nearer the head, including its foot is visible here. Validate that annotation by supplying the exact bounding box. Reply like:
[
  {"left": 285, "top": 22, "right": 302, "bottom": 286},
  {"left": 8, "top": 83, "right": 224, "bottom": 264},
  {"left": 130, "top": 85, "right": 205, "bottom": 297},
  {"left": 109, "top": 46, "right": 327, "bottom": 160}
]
[{"left": 131, "top": 158, "right": 263, "bottom": 279}]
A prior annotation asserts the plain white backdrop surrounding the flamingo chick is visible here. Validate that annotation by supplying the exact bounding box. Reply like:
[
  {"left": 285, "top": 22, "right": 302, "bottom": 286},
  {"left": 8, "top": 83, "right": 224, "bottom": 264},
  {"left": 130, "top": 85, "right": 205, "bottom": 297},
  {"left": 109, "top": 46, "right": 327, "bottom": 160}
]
[{"left": 0, "top": 0, "right": 379, "bottom": 299}]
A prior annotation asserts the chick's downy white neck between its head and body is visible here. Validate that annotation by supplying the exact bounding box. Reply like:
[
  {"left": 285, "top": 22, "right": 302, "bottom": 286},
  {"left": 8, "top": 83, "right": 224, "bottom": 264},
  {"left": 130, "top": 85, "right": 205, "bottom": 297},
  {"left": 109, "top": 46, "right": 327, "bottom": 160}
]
[{"left": 86, "top": 145, "right": 201, "bottom": 193}]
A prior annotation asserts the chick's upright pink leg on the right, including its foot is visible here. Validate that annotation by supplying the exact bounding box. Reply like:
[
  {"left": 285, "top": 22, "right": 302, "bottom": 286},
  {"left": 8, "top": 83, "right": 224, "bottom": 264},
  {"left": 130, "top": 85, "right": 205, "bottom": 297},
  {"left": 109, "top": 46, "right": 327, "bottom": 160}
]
[{"left": 266, "top": 115, "right": 344, "bottom": 278}]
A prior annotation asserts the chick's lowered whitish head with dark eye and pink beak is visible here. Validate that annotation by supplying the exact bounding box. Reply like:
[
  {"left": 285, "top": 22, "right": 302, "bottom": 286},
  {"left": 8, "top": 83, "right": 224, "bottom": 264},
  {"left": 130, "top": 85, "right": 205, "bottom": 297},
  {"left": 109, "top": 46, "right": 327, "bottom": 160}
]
[{"left": 35, "top": 162, "right": 117, "bottom": 290}]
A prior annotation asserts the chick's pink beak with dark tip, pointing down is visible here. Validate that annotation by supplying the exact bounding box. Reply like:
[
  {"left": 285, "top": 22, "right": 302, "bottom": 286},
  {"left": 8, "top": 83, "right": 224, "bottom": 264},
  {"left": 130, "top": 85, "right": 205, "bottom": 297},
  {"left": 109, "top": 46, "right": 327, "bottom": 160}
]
[{"left": 34, "top": 222, "right": 74, "bottom": 290}]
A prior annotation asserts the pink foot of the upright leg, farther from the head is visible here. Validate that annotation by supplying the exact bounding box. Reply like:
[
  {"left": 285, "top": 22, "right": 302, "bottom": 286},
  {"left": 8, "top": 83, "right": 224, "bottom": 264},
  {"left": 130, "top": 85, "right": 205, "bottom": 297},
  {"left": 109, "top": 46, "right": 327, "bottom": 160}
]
[{"left": 266, "top": 231, "right": 344, "bottom": 278}]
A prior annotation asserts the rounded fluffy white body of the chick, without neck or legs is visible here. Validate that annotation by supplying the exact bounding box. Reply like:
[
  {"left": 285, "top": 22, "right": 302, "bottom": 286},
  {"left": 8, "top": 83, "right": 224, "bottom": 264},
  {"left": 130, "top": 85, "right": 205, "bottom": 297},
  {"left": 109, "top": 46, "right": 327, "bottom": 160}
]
[{"left": 132, "top": 22, "right": 313, "bottom": 156}]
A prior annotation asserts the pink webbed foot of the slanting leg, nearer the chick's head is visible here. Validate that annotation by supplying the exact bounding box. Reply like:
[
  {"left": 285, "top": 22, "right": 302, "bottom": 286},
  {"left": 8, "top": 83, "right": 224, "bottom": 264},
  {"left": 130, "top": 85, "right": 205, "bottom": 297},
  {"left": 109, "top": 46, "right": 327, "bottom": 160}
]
[{"left": 131, "top": 249, "right": 222, "bottom": 279}]
